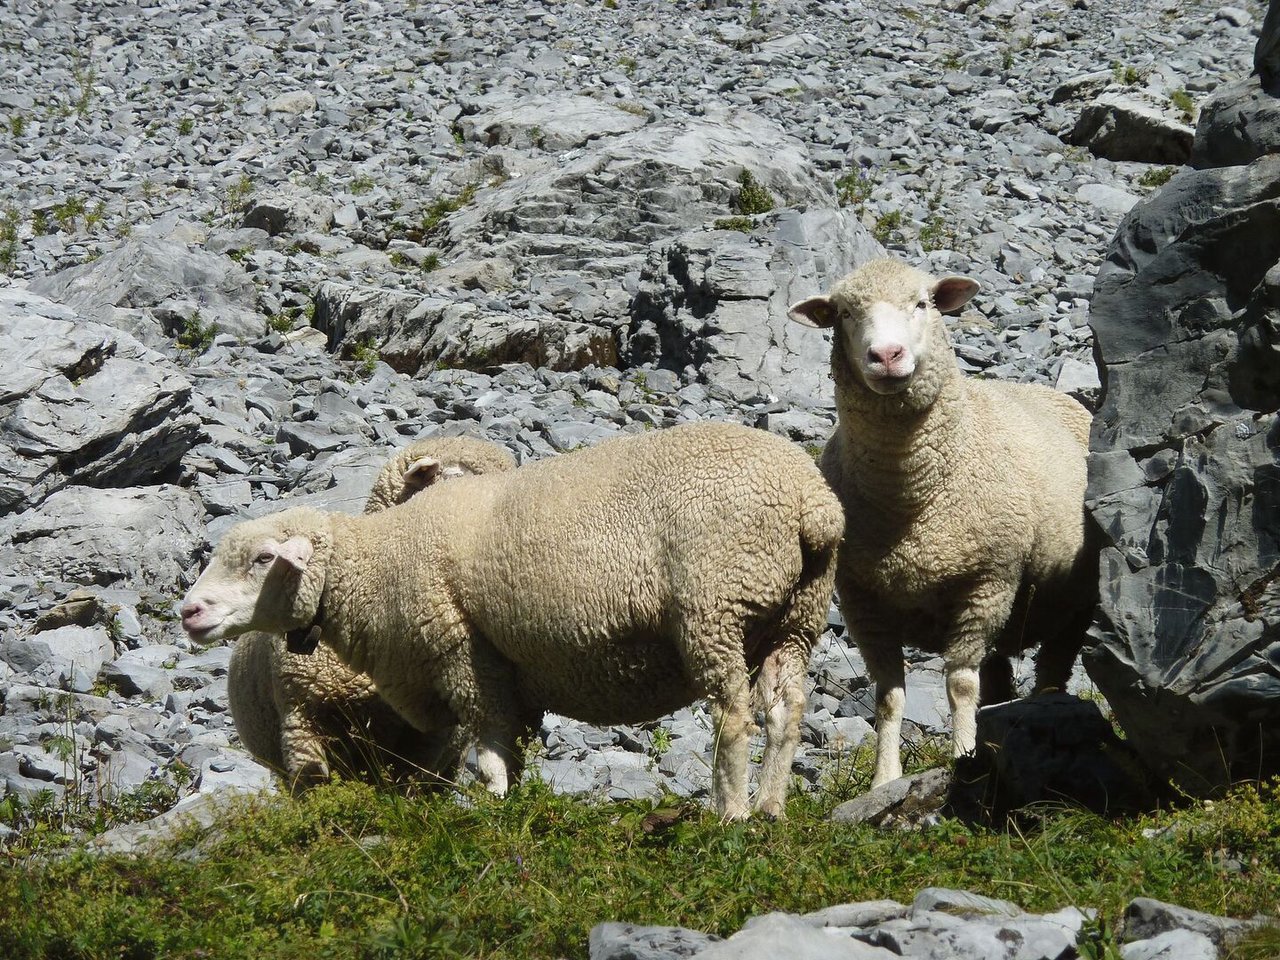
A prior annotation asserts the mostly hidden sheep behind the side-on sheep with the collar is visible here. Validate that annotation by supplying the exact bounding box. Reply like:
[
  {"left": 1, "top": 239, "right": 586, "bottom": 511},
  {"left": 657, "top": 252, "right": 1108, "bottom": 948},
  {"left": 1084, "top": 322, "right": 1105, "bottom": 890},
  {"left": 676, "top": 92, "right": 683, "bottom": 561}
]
[{"left": 227, "top": 436, "right": 516, "bottom": 790}]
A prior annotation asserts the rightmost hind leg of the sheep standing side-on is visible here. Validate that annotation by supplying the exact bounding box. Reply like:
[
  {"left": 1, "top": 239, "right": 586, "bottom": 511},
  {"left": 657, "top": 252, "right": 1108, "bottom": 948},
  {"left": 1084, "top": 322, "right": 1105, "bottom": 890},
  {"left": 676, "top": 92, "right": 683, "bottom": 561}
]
[{"left": 755, "top": 639, "right": 812, "bottom": 819}]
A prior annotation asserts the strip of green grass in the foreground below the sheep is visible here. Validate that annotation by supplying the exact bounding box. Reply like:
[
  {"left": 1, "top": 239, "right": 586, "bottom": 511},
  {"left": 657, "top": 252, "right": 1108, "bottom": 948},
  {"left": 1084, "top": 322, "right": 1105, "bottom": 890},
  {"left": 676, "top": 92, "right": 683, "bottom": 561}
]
[{"left": 0, "top": 783, "right": 1280, "bottom": 960}]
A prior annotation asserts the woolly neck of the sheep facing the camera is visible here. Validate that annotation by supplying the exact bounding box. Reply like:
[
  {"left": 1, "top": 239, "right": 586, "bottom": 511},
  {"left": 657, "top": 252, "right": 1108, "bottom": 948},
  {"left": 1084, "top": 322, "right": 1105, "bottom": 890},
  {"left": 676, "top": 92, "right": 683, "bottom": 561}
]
[{"left": 836, "top": 360, "right": 969, "bottom": 516}]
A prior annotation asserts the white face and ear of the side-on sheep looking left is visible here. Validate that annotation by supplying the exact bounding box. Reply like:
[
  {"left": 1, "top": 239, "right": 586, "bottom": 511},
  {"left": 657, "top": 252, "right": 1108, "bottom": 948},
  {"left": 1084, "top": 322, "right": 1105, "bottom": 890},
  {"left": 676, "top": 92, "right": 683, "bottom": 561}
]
[{"left": 182, "top": 525, "right": 314, "bottom": 643}]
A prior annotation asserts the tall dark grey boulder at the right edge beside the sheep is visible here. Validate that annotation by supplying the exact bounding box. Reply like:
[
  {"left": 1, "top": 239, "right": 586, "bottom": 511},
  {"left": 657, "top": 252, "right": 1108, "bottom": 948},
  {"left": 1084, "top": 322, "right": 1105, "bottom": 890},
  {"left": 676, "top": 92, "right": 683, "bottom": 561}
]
[{"left": 1085, "top": 22, "right": 1280, "bottom": 792}]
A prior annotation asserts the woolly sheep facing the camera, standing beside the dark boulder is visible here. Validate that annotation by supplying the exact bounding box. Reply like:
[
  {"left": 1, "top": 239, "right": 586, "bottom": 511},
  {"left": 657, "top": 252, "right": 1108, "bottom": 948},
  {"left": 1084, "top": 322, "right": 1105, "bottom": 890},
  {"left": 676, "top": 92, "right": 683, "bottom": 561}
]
[{"left": 790, "top": 260, "right": 1097, "bottom": 786}]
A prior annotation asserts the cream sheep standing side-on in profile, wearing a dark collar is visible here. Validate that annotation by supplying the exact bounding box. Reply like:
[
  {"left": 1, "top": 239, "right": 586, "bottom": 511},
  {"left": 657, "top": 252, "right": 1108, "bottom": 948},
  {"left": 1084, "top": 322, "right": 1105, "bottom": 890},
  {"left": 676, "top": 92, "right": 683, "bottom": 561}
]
[{"left": 182, "top": 424, "right": 844, "bottom": 819}]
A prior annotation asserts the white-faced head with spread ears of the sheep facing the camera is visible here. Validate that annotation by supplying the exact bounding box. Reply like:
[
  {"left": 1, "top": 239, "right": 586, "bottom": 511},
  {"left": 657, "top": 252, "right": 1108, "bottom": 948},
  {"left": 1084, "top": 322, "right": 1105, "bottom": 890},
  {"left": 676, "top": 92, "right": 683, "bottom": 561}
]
[{"left": 788, "top": 260, "right": 978, "bottom": 394}]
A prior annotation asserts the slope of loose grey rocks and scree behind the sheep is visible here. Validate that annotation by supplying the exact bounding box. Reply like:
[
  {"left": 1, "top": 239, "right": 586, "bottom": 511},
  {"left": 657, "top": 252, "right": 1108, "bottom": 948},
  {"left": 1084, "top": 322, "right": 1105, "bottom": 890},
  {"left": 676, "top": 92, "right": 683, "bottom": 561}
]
[{"left": 0, "top": 0, "right": 1263, "bottom": 957}]
